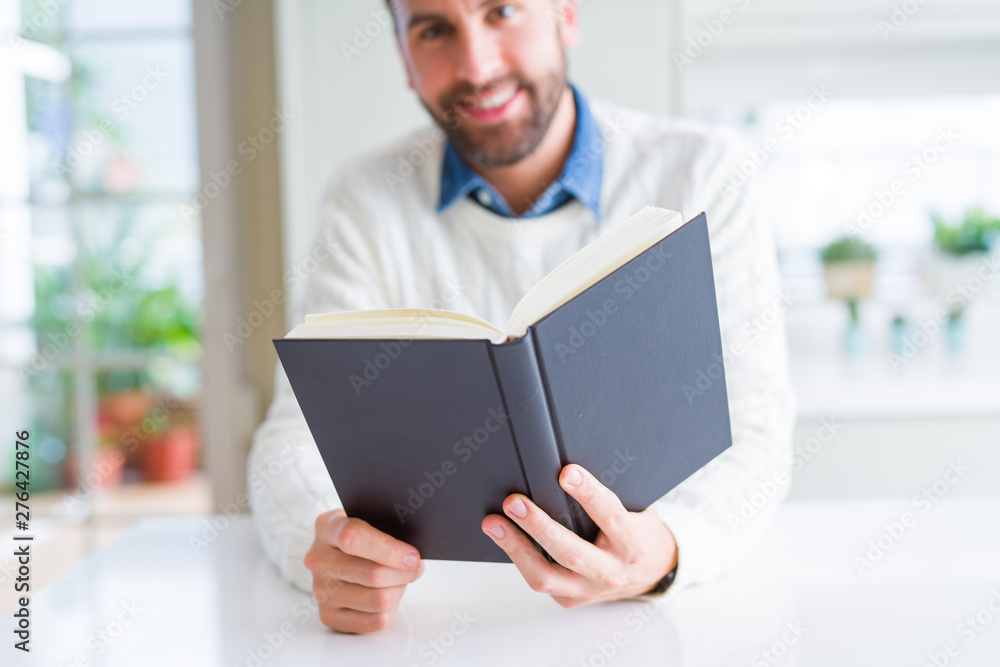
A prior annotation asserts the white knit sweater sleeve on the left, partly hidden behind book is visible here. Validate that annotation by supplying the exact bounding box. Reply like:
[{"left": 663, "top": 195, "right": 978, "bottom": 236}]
[{"left": 247, "top": 170, "right": 389, "bottom": 591}]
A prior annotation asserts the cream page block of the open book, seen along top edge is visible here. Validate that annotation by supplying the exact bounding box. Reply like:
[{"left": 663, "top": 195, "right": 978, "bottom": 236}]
[{"left": 287, "top": 206, "right": 683, "bottom": 343}]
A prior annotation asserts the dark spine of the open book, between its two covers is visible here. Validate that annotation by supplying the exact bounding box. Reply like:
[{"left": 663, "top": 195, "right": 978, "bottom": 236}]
[{"left": 489, "top": 329, "right": 579, "bottom": 534}]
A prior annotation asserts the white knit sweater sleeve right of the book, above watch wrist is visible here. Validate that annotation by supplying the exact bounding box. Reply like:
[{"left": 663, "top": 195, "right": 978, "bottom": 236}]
[{"left": 655, "top": 133, "right": 795, "bottom": 598}]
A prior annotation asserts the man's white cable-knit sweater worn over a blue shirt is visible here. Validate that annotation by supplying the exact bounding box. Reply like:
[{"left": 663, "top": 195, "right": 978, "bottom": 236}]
[{"left": 247, "top": 100, "right": 794, "bottom": 597}]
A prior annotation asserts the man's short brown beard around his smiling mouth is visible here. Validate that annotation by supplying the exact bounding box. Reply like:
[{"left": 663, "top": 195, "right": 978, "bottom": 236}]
[{"left": 420, "top": 61, "right": 567, "bottom": 168}]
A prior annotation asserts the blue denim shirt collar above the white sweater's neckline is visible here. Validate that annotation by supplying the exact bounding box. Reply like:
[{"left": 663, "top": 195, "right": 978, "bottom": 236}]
[{"left": 437, "top": 84, "right": 604, "bottom": 219}]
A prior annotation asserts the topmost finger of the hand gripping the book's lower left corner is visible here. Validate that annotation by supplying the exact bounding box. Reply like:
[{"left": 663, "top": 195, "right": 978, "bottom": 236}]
[{"left": 316, "top": 509, "right": 420, "bottom": 570}]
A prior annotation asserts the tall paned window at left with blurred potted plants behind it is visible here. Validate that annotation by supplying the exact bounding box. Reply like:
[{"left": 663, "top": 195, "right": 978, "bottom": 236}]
[{"left": 0, "top": 0, "right": 204, "bottom": 506}]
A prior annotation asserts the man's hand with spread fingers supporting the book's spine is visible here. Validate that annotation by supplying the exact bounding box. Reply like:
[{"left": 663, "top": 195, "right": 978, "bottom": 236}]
[{"left": 482, "top": 464, "right": 677, "bottom": 607}]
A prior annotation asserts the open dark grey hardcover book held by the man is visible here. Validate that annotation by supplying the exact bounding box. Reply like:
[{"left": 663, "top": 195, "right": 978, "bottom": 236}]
[{"left": 274, "top": 207, "right": 732, "bottom": 562}]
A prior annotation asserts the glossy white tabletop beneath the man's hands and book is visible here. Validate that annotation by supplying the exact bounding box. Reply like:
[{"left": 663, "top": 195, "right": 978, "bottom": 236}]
[{"left": 0, "top": 498, "right": 1000, "bottom": 667}]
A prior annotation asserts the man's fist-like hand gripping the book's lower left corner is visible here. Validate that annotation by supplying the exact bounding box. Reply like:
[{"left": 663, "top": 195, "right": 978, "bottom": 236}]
[{"left": 304, "top": 509, "right": 424, "bottom": 634}]
